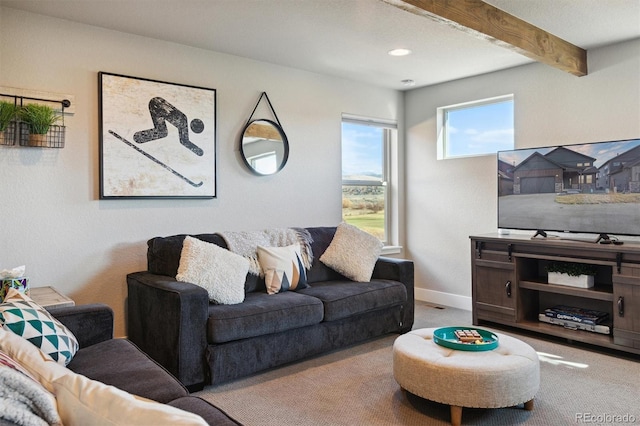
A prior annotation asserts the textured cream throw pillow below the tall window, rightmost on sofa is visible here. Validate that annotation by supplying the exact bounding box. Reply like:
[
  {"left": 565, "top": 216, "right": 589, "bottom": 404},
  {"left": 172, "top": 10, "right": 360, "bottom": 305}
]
[{"left": 320, "top": 222, "right": 382, "bottom": 282}]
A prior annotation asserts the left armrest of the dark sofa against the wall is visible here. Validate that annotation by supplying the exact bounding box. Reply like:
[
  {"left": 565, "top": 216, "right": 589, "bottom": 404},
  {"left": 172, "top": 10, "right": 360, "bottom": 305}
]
[{"left": 127, "top": 272, "right": 209, "bottom": 389}]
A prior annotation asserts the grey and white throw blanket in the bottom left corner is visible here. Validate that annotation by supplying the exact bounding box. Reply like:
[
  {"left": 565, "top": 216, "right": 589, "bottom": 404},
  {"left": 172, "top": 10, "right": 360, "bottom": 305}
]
[{"left": 0, "top": 365, "right": 62, "bottom": 426}]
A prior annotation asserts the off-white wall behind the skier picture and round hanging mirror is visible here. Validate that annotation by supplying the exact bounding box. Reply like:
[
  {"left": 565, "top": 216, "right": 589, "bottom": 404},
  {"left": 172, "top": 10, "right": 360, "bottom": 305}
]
[{"left": 0, "top": 8, "right": 403, "bottom": 336}]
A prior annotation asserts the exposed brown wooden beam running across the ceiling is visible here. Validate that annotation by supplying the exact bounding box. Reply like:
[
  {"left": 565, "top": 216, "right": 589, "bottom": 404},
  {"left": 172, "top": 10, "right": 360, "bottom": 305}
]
[{"left": 382, "top": 0, "right": 587, "bottom": 77}]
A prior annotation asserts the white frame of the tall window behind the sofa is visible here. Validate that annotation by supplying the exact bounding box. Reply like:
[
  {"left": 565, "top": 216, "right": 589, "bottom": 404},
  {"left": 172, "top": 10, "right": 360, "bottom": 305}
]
[{"left": 340, "top": 113, "right": 398, "bottom": 246}]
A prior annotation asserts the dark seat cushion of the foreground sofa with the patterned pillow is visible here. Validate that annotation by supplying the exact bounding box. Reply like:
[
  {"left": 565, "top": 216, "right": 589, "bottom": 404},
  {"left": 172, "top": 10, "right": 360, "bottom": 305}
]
[{"left": 68, "top": 339, "right": 188, "bottom": 402}]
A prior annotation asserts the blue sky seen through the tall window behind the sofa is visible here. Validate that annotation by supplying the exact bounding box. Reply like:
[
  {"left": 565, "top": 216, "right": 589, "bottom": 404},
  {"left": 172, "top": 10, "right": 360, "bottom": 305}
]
[{"left": 342, "top": 123, "right": 384, "bottom": 177}]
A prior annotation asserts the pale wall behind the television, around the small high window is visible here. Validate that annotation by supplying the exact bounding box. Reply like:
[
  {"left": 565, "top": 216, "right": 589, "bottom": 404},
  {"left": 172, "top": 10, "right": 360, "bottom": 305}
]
[{"left": 405, "top": 39, "right": 640, "bottom": 309}]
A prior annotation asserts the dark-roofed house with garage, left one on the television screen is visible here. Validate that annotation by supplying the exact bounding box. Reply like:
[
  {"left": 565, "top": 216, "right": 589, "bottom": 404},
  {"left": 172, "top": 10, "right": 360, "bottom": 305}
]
[{"left": 513, "top": 146, "right": 598, "bottom": 194}]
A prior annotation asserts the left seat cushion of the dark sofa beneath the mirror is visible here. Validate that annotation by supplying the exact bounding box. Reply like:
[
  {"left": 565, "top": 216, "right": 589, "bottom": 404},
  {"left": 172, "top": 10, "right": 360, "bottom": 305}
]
[{"left": 207, "top": 290, "right": 323, "bottom": 343}]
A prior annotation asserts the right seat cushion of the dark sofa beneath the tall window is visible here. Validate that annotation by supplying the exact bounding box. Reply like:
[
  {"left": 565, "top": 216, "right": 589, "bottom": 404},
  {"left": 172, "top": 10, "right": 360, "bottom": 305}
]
[{"left": 299, "top": 280, "right": 407, "bottom": 321}]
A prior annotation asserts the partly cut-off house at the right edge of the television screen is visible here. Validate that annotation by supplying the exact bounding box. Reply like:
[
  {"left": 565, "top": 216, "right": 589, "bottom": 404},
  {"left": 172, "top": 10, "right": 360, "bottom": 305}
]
[{"left": 597, "top": 145, "right": 640, "bottom": 192}]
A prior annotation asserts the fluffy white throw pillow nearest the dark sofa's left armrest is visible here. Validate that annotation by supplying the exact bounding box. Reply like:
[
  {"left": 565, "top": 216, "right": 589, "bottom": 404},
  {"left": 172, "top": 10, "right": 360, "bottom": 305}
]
[{"left": 176, "top": 236, "right": 249, "bottom": 305}]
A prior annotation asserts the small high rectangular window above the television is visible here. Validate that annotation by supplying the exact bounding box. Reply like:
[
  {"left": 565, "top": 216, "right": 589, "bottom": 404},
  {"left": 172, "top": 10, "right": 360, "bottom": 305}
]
[{"left": 437, "top": 95, "right": 514, "bottom": 160}]
